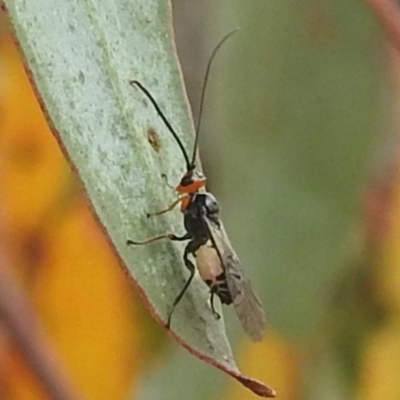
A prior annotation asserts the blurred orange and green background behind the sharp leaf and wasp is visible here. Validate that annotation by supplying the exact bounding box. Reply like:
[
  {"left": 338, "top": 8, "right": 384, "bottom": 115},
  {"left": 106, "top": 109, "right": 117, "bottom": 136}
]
[{"left": 0, "top": 0, "right": 400, "bottom": 400}]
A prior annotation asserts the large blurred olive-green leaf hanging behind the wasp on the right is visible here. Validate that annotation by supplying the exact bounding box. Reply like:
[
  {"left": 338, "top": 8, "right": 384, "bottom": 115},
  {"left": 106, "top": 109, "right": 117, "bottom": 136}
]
[{"left": 216, "top": 0, "right": 386, "bottom": 343}]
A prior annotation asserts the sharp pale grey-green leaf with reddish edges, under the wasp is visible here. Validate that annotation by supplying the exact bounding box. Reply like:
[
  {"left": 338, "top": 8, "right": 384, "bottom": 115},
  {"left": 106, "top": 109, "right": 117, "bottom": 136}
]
[{"left": 5, "top": 0, "right": 273, "bottom": 396}]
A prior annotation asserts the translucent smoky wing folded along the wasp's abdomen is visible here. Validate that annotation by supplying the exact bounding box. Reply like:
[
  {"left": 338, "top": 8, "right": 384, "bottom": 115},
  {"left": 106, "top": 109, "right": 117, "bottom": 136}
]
[{"left": 204, "top": 216, "right": 265, "bottom": 342}]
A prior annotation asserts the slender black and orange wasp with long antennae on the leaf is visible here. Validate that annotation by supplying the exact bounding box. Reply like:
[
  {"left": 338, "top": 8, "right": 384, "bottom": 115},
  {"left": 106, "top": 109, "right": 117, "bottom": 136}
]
[{"left": 127, "top": 29, "right": 265, "bottom": 341}]
